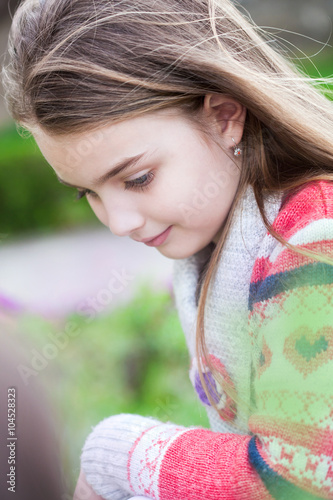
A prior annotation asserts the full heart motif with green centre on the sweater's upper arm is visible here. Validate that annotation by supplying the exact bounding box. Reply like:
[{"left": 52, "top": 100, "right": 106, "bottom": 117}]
[{"left": 283, "top": 326, "right": 333, "bottom": 378}]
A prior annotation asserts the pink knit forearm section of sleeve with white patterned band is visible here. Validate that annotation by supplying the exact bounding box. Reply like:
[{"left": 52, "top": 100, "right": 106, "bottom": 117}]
[{"left": 128, "top": 425, "right": 272, "bottom": 500}]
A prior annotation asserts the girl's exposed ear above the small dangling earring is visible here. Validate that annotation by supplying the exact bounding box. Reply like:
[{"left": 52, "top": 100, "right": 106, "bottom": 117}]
[{"left": 203, "top": 94, "right": 246, "bottom": 147}]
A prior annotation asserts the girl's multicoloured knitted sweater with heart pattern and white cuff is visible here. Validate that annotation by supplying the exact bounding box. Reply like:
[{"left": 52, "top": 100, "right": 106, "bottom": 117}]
[{"left": 82, "top": 182, "right": 333, "bottom": 500}]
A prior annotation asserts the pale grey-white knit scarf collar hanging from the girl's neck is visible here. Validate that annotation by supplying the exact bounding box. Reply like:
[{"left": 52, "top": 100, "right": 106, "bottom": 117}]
[{"left": 173, "top": 187, "right": 282, "bottom": 433}]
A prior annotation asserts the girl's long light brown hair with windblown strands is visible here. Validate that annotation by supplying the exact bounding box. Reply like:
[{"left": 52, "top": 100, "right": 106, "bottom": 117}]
[{"left": 3, "top": 0, "right": 333, "bottom": 416}]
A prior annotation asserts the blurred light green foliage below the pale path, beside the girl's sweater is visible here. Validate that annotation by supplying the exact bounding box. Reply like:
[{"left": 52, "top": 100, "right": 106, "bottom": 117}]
[{"left": 15, "top": 286, "right": 209, "bottom": 494}]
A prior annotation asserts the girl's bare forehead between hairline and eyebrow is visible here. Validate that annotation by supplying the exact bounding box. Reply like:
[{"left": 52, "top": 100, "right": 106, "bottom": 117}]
[{"left": 33, "top": 109, "right": 196, "bottom": 180}]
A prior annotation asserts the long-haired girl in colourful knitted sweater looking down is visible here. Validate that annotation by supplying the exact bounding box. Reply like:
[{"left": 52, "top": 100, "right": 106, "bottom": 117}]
[{"left": 4, "top": 0, "right": 333, "bottom": 500}]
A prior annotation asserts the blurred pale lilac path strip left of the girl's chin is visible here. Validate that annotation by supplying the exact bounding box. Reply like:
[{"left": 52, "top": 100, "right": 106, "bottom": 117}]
[{"left": 0, "top": 228, "right": 172, "bottom": 318}]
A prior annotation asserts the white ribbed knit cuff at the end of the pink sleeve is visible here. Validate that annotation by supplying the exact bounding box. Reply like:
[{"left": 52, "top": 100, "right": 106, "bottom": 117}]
[{"left": 81, "top": 414, "right": 184, "bottom": 500}]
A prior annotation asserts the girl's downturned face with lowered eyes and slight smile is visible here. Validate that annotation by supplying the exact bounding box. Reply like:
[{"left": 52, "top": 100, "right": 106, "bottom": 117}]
[{"left": 35, "top": 110, "right": 240, "bottom": 259}]
